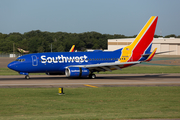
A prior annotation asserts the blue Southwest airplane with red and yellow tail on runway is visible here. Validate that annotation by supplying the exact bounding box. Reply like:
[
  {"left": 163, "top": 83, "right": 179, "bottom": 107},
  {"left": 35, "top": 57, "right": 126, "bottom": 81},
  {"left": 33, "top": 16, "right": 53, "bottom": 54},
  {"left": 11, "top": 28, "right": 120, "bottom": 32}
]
[{"left": 8, "top": 16, "right": 158, "bottom": 79}]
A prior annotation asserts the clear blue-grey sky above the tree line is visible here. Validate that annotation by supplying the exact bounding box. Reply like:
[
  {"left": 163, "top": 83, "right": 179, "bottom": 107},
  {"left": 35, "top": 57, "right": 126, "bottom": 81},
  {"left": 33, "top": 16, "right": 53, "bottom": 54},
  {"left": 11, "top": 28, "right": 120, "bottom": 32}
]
[{"left": 0, "top": 0, "right": 180, "bottom": 36}]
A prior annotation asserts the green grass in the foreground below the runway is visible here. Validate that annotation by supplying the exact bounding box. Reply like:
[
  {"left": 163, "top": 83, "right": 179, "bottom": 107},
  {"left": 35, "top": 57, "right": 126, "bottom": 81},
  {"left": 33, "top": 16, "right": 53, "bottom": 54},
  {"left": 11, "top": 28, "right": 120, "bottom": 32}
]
[{"left": 0, "top": 87, "right": 180, "bottom": 120}]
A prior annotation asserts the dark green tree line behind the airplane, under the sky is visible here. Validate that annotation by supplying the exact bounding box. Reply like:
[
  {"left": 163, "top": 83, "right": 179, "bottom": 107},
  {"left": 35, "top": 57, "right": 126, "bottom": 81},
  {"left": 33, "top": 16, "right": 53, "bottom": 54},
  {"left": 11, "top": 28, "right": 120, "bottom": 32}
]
[{"left": 0, "top": 30, "right": 180, "bottom": 53}]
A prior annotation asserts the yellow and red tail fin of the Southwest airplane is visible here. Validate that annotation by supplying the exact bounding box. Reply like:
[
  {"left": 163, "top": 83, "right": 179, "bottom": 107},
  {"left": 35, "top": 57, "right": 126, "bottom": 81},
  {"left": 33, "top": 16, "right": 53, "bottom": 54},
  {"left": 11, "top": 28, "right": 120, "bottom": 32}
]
[{"left": 120, "top": 16, "right": 158, "bottom": 62}]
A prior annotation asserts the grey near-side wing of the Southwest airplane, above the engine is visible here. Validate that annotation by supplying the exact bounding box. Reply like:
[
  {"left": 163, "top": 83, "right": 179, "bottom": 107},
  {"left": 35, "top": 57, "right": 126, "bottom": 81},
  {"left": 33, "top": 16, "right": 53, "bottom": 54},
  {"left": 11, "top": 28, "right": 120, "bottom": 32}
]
[{"left": 68, "top": 61, "right": 141, "bottom": 72}]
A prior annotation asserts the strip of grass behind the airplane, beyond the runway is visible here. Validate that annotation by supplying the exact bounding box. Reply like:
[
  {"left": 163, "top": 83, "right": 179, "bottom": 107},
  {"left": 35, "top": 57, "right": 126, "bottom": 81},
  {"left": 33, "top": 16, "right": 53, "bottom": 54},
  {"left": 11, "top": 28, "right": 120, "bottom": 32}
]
[{"left": 0, "top": 66, "right": 180, "bottom": 75}]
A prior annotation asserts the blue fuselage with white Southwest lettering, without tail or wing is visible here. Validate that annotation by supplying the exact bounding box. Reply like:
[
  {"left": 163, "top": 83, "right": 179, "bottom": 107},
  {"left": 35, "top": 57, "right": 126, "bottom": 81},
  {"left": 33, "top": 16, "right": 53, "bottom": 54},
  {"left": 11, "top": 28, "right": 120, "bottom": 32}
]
[{"left": 8, "top": 49, "right": 122, "bottom": 73}]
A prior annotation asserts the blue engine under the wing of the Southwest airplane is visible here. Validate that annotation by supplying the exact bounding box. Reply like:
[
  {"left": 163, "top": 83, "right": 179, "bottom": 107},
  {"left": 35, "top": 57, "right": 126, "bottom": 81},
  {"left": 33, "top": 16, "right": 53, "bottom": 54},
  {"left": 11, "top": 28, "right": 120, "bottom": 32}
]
[{"left": 65, "top": 67, "right": 89, "bottom": 77}]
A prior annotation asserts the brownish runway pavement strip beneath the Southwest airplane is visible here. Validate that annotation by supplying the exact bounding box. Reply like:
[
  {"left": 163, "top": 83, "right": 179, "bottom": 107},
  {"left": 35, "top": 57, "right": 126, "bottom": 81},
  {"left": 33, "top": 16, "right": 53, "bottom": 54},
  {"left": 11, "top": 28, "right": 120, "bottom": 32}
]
[{"left": 0, "top": 74, "right": 180, "bottom": 88}]
